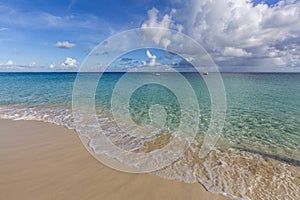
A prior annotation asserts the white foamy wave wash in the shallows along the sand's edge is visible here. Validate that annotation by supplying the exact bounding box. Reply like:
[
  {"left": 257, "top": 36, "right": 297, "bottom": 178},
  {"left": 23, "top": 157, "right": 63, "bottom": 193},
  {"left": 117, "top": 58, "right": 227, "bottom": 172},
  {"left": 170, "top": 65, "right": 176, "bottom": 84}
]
[{"left": 0, "top": 105, "right": 300, "bottom": 200}]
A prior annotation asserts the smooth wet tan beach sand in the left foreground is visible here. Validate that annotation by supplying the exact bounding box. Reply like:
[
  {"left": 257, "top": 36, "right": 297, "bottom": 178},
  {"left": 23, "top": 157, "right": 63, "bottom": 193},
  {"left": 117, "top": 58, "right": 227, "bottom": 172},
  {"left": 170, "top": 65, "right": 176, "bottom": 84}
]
[{"left": 0, "top": 120, "right": 229, "bottom": 200}]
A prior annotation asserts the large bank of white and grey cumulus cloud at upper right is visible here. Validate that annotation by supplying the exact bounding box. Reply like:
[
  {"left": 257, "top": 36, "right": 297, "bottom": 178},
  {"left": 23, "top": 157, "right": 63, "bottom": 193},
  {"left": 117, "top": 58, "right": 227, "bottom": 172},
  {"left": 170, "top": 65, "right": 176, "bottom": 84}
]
[{"left": 141, "top": 0, "right": 300, "bottom": 70}]
